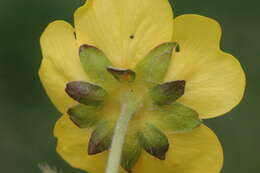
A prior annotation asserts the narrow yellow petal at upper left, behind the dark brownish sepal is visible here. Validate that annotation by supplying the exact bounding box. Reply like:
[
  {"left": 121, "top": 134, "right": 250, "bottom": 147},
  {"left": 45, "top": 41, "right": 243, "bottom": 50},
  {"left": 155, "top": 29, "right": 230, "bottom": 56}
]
[{"left": 39, "top": 21, "right": 86, "bottom": 112}]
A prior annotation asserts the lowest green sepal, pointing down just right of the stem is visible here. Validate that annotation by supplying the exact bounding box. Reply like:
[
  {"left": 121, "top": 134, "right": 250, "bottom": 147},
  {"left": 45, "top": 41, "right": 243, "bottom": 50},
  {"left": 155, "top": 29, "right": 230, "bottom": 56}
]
[{"left": 121, "top": 136, "right": 142, "bottom": 173}]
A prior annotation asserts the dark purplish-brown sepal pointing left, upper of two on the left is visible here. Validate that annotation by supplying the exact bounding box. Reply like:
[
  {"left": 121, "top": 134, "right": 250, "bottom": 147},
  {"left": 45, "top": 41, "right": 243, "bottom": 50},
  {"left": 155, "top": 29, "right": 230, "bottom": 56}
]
[{"left": 65, "top": 81, "right": 107, "bottom": 106}]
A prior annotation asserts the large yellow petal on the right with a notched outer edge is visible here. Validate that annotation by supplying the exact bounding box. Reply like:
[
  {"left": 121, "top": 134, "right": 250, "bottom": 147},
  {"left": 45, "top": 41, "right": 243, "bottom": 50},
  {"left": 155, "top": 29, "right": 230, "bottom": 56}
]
[{"left": 166, "top": 15, "right": 245, "bottom": 118}]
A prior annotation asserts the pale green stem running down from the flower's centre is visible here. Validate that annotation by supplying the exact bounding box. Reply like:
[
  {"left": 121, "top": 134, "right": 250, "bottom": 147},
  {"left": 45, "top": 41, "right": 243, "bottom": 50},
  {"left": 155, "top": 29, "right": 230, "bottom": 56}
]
[{"left": 106, "top": 94, "right": 137, "bottom": 173}]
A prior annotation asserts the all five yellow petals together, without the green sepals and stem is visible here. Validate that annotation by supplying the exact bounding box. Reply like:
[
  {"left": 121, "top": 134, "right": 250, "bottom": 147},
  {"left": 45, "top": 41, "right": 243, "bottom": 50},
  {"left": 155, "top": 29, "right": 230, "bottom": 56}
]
[{"left": 39, "top": 0, "right": 245, "bottom": 173}]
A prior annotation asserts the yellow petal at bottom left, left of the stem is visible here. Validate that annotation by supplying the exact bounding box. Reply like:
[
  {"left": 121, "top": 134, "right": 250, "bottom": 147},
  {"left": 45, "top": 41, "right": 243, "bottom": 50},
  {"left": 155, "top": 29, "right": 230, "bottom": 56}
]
[{"left": 54, "top": 115, "right": 108, "bottom": 173}]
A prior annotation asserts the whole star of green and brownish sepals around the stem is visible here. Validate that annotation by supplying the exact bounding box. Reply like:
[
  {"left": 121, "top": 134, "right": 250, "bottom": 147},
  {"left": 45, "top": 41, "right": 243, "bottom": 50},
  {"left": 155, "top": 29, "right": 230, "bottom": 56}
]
[{"left": 65, "top": 42, "right": 202, "bottom": 172}]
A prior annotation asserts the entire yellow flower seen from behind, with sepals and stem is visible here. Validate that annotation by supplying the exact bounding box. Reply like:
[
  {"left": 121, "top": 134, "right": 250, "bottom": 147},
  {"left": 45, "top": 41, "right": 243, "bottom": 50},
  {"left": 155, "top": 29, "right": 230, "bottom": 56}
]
[{"left": 39, "top": 0, "right": 245, "bottom": 170}]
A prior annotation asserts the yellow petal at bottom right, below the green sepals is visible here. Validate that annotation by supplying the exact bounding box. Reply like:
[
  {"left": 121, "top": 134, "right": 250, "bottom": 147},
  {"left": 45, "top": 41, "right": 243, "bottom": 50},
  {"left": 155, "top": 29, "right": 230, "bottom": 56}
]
[{"left": 133, "top": 125, "right": 223, "bottom": 173}]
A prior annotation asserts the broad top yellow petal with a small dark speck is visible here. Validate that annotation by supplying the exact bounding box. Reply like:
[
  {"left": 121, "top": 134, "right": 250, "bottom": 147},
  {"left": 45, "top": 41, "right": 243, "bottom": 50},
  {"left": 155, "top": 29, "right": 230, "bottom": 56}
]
[{"left": 75, "top": 0, "right": 173, "bottom": 68}]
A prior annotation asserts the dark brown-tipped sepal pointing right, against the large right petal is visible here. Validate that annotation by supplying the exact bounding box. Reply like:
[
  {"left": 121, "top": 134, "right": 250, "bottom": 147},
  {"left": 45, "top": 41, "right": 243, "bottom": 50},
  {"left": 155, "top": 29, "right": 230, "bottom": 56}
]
[{"left": 150, "top": 80, "right": 185, "bottom": 105}]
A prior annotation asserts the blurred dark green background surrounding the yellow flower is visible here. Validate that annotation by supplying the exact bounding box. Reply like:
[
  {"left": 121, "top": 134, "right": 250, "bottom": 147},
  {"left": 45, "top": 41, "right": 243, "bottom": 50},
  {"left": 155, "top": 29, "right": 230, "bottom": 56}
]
[{"left": 0, "top": 0, "right": 260, "bottom": 173}]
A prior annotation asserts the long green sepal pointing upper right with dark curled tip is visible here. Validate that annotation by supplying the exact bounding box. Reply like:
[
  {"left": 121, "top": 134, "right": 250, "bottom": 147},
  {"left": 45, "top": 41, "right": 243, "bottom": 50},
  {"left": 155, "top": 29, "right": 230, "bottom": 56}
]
[{"left": 135, "top": 42, "right": 178, "bottom": 87}]
